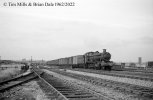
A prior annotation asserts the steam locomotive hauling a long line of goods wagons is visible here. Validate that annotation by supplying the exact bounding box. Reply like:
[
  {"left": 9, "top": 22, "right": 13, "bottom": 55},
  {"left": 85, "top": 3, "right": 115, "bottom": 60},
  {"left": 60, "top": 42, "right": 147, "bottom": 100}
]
[{"left": 46, "top": 49, "right": 114, "bottom": 70}]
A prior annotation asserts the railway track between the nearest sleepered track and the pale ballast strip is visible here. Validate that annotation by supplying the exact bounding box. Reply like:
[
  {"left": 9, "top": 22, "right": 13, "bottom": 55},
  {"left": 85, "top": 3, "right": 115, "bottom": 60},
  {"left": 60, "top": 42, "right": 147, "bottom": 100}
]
[{"left": 48, "top": 70, "right": 153, "bottom": 100}]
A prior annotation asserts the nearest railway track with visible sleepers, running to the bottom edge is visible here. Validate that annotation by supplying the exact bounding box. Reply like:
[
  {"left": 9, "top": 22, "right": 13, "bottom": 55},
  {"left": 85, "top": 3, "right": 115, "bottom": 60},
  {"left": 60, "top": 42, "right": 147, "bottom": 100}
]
[{"left": 31, "top": 69, "right": 114, "bottom": 100}]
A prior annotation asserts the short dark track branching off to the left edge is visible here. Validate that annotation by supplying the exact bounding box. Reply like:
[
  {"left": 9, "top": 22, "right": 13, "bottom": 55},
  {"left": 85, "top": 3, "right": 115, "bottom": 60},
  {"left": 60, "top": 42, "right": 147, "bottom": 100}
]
[{"left": 0, "top": 72, "right": 40, "bottom": 93}]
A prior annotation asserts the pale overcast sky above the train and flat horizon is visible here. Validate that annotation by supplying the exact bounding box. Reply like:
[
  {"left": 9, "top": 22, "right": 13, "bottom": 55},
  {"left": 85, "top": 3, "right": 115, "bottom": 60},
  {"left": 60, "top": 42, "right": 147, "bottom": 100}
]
[{"left": 0, "top": 0, "right": 153, "bottom": 62}]
